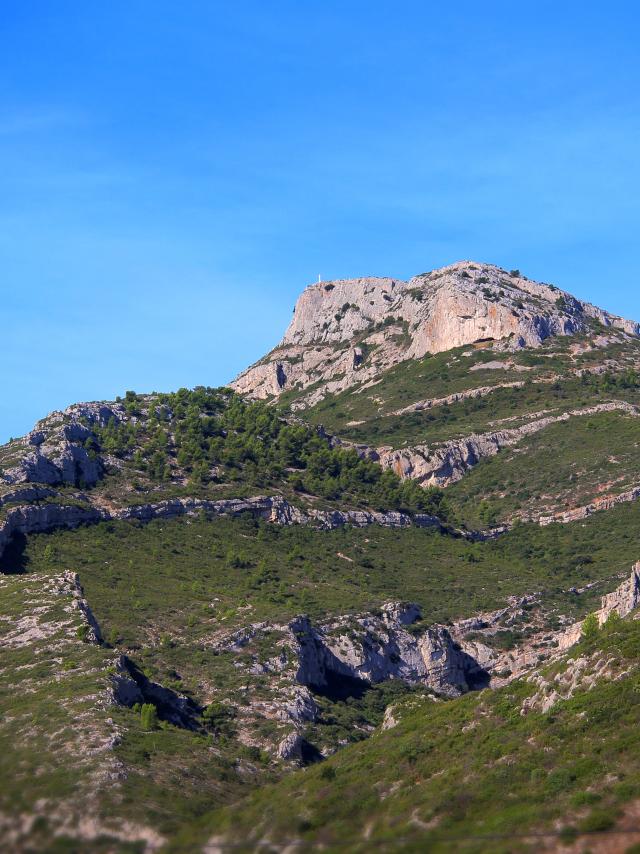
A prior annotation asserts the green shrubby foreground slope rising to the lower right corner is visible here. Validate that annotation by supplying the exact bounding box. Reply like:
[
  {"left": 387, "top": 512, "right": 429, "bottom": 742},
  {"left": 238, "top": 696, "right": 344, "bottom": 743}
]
[{"left": 180, "top": 621, "right": 640, "bottom": 854}]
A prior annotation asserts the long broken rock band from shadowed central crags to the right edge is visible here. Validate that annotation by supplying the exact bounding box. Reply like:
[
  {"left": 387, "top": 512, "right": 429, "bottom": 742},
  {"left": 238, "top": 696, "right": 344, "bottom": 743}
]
[{"left": 215, "top": 563, "right": 640, "bottom": 726}]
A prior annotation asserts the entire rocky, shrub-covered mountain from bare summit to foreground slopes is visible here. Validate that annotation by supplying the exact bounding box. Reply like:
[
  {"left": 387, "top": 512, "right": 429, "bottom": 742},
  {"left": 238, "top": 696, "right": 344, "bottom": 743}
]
[{"left": 0, "top": 262, "right": 640, "bottom": 854}]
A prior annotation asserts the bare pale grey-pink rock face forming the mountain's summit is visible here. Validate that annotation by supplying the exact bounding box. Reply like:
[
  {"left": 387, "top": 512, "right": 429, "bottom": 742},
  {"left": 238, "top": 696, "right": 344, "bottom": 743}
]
[{"left": 232, "top": 261, "right": 640, "bottom": 406}]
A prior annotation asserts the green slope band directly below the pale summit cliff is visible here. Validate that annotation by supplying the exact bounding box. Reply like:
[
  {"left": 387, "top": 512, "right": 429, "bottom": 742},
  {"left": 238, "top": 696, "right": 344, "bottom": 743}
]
[{"left": 296, "top": 339, "right": 640, "bottom": 447}]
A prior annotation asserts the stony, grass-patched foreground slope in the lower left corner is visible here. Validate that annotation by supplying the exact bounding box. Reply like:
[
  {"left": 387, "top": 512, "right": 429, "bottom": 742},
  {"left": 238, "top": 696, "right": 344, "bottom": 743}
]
[{"left": 0, "top": 569, "right": 282, "bottom": 851}]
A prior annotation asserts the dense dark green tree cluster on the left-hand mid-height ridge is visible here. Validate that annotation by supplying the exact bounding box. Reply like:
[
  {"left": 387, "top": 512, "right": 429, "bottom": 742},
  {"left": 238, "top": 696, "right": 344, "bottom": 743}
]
[{"left": 98, "top": 387, "right": 447, "bottom": 518}]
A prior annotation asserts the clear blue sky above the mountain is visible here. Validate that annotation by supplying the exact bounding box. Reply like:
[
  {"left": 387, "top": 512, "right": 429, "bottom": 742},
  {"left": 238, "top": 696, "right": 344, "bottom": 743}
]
[{"left": 0, "top": 0, "right": 640, "bottom": 440}]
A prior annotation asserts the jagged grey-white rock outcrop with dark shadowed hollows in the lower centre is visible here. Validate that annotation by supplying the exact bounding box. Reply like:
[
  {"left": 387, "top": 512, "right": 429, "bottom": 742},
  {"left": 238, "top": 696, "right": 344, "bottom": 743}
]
[{"left": 215, "top": 602, "right": 489, "bottom": 704}]
